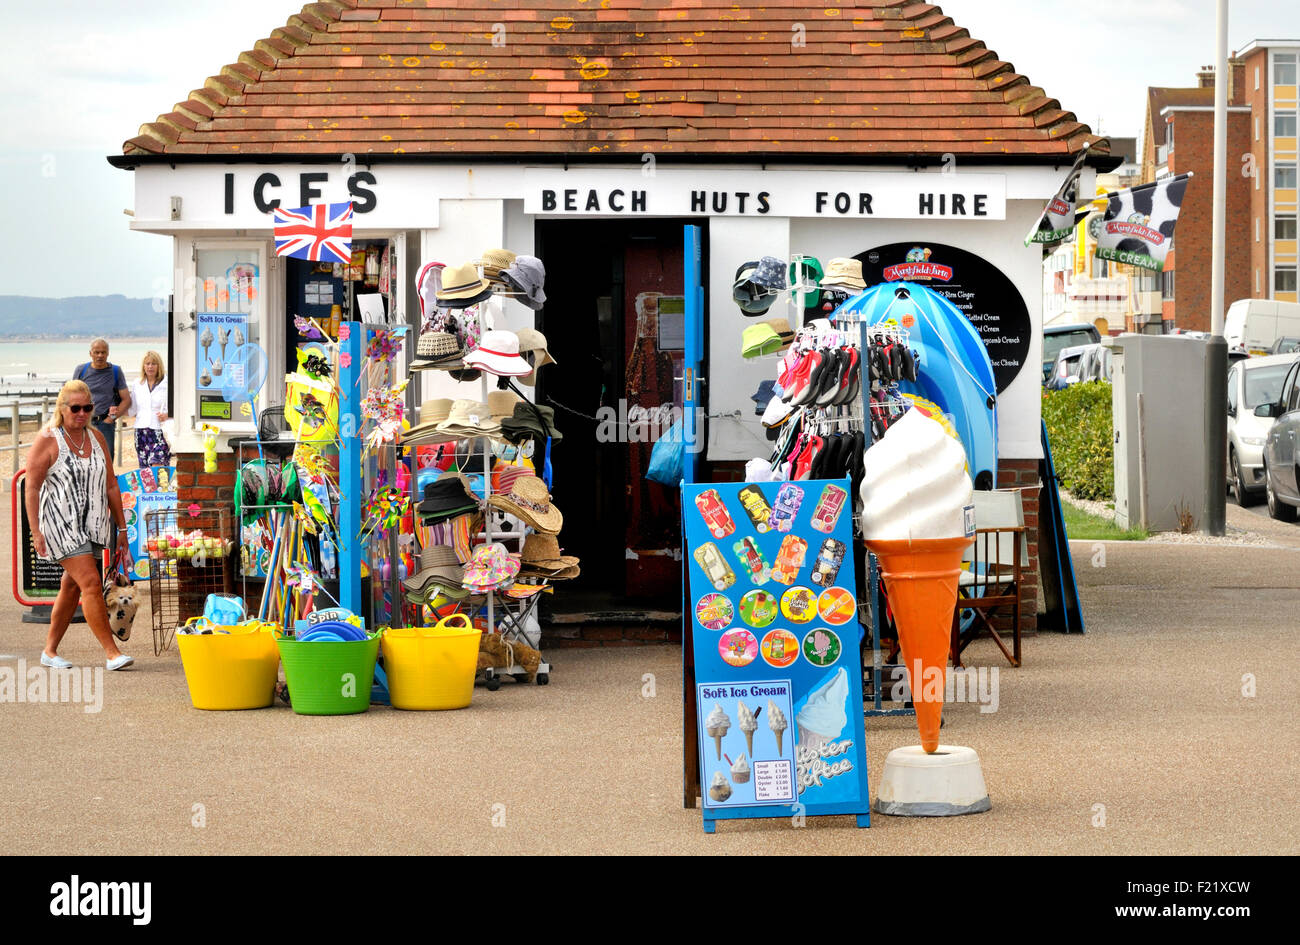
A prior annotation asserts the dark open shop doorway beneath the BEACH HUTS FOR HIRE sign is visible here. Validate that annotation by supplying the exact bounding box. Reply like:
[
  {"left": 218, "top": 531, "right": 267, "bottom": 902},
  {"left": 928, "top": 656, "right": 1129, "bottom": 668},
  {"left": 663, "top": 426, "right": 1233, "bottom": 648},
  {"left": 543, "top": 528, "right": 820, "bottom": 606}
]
[{"left": 536, "top": 220, "right": 707, "bottom": 612}]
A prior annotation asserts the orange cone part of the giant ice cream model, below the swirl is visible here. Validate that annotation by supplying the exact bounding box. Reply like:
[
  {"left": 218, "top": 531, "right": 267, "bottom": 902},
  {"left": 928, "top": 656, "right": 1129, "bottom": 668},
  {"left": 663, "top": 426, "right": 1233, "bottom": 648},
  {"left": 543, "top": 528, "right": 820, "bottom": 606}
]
[{"left": 867, "top": 538, "right": 971, "bottom": 754}]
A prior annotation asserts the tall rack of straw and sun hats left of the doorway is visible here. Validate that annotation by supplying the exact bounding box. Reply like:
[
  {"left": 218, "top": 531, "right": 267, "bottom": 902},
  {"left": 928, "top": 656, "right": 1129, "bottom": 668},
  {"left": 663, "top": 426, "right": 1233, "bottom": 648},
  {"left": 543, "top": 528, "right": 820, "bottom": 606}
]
[{"left": 400, "top": 250, "right": 561, "bottom": 690}]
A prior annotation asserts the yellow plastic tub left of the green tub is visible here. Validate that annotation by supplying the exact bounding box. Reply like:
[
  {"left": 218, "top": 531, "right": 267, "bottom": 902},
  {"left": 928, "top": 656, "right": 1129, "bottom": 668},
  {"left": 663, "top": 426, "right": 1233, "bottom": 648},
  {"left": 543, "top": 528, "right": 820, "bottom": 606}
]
[{"left": 176, "top": 627, "right": 280, "bottom": 710}]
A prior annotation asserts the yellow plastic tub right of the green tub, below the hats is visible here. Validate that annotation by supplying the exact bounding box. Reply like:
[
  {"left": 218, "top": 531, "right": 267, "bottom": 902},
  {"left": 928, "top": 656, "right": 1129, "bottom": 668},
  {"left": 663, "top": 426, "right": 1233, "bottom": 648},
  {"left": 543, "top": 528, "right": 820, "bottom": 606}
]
[{"left": 384, "top": 615, "right": 482, "bottom": 710}]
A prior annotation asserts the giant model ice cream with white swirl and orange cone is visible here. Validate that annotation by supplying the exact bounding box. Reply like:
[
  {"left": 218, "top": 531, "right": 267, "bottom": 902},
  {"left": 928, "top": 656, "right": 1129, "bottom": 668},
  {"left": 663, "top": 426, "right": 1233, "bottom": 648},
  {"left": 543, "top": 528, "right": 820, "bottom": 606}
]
[{"left": 862, "top": 409, "right": 971, "bottom": 753}]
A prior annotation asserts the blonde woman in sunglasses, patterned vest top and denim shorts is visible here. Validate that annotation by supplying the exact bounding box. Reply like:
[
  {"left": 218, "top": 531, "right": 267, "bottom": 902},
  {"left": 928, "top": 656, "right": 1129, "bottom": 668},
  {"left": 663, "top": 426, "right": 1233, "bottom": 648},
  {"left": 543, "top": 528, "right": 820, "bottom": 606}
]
[{"left": 26, "top": 381, "right": 134, "bottom": 669}]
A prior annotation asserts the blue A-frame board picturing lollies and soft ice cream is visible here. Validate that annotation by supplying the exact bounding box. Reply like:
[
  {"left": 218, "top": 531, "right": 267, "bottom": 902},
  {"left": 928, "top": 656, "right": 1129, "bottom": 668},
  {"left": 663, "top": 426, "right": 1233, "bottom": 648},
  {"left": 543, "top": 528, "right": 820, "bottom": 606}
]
[{"left": 681, "top": 480, "right": 871, "bottom": 833}]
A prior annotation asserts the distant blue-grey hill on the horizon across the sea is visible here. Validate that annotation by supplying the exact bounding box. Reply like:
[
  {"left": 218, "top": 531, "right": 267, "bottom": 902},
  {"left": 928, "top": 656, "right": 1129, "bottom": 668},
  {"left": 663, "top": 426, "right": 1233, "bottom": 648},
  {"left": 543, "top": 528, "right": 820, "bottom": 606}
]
[{"left": 0, "top": 295, "right": 166, "bottom": 338}]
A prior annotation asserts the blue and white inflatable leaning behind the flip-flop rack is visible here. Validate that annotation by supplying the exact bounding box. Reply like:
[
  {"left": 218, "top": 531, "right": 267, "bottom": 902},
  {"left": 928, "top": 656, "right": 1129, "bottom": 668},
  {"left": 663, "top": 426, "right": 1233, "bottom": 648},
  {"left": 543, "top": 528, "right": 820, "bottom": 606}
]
[{"left": 831, "top": 282, "right": 997, "bottom": 489}]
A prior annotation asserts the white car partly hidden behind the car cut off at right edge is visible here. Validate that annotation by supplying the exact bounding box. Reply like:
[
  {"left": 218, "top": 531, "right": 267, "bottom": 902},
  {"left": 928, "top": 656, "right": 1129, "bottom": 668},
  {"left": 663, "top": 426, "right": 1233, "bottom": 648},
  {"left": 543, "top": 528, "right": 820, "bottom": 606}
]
[{"left": 1227, "top": 355, "right": 1296, "bottom": 506}]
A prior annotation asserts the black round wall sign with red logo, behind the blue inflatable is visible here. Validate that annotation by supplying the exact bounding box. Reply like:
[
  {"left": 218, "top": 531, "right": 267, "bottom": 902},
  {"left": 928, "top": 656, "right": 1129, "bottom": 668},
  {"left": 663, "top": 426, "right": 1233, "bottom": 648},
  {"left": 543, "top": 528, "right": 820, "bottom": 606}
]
[{"left": 855, "top": 240, "right": 1032, "bottom": 394}]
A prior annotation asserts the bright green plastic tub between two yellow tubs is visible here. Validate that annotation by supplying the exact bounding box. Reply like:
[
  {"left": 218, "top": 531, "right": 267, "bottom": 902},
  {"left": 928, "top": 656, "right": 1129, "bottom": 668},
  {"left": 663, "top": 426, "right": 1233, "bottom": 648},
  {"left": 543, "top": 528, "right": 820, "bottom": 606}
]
[{"left": 277, "top": 633, "right": 380, "bottom": 715}]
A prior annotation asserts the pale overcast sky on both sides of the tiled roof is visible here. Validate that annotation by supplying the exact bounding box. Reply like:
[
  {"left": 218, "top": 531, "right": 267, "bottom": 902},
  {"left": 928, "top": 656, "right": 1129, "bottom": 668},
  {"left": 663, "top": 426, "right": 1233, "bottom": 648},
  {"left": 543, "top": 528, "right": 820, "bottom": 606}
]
[{"left": 0, "top": 0, "right": 1279, "bottom": 298}]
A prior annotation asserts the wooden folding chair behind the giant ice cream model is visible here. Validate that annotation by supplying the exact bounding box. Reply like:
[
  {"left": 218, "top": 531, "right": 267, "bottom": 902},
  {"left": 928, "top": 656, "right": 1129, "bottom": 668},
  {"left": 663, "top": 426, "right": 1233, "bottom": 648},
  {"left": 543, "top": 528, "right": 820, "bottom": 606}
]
[{"left": 952, "top": 489, "right": 1028, "bottom": 667}]
